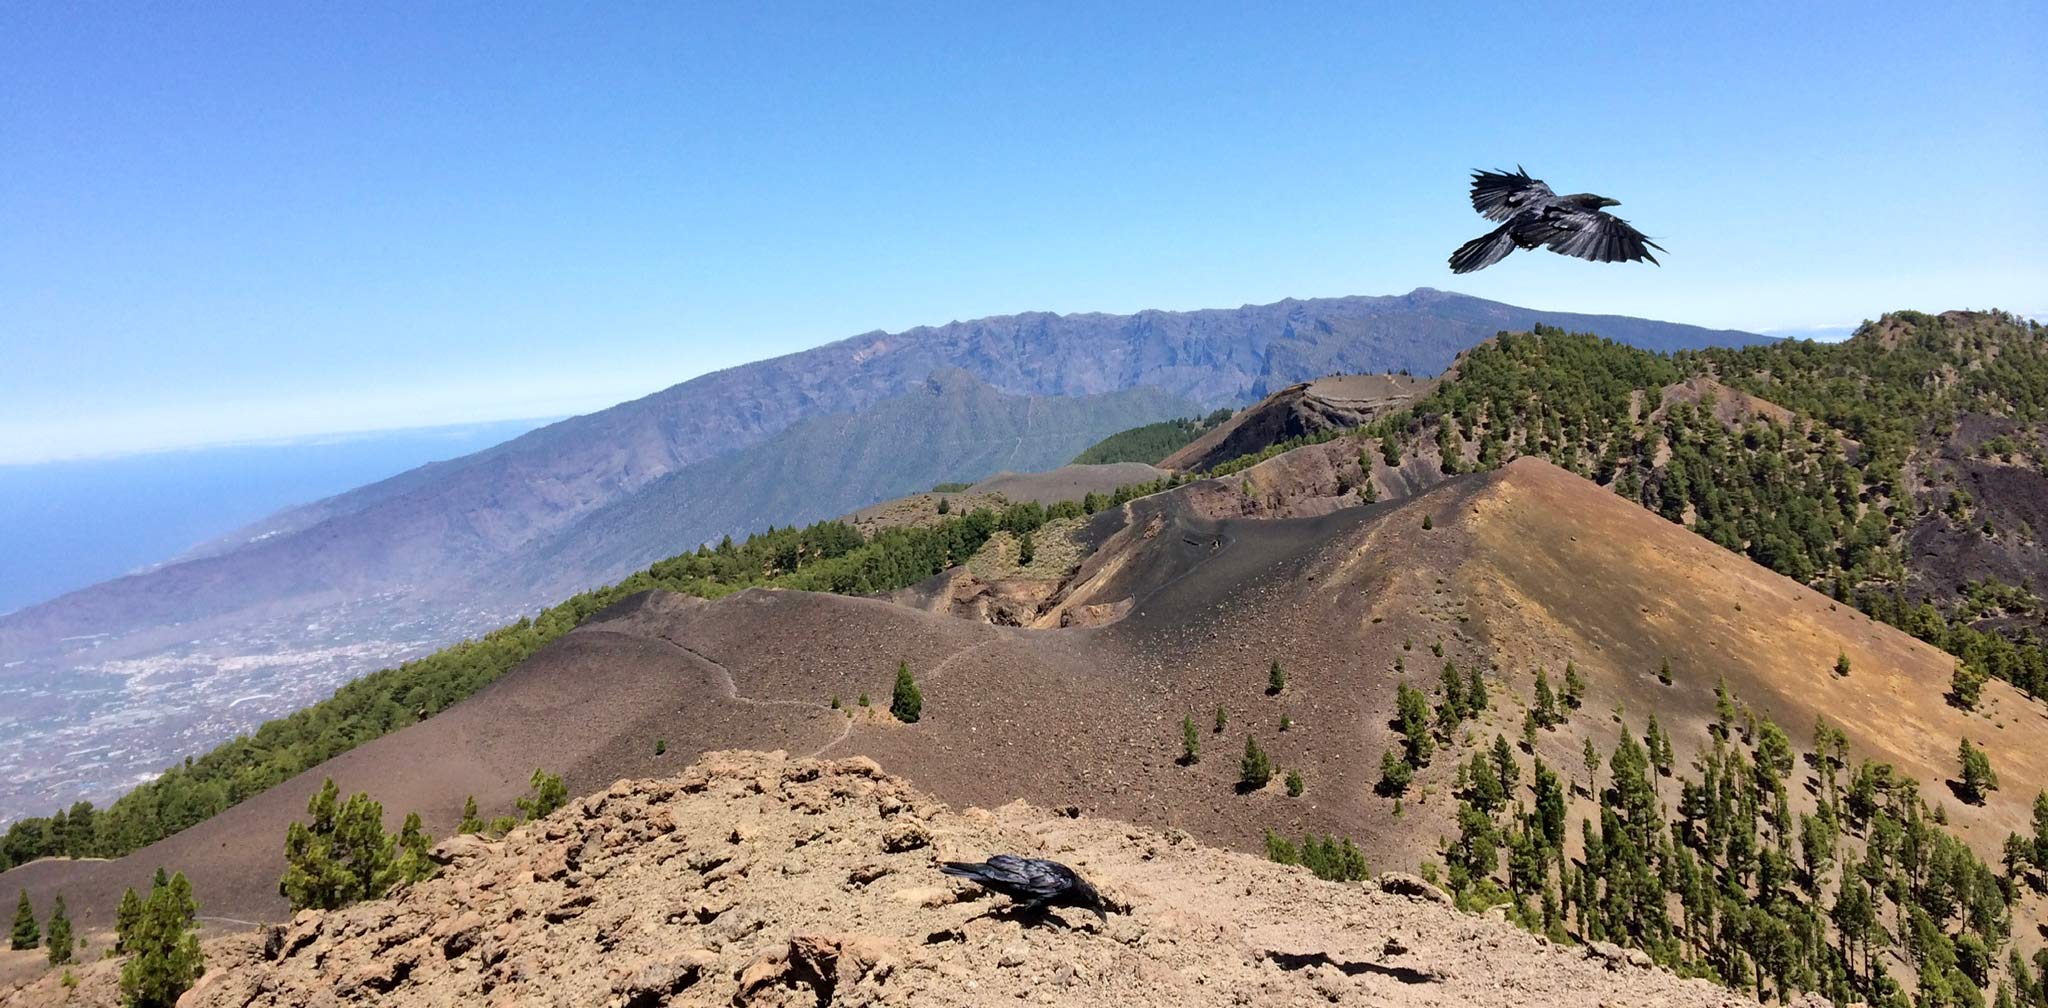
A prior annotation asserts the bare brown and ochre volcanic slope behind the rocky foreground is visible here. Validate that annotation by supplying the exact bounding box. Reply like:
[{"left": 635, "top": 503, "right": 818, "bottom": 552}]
[{"left": 12, "top": 449, "right": 2048, "bottom": 942}]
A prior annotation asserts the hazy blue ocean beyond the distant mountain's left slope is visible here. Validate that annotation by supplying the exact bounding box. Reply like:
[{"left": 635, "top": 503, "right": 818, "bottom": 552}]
[{"left": 0, "top": 420, "right": 551, "bottom": 613}]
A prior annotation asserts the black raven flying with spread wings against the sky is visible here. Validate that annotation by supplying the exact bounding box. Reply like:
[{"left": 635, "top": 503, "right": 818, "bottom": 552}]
[{"left": 1450, "top": 164, "right": 1663, "bottom": 272}]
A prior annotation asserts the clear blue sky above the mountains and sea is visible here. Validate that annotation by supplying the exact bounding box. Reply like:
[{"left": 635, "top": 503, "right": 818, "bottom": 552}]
[{"left": 0, "top": 0, "right": 2048, "bottom": 461}]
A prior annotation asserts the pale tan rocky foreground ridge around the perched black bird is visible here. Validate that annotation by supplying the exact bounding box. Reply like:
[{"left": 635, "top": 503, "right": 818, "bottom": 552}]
[{"left": 0, "top": 752, "right": 1818, "bottom": 1008}]
